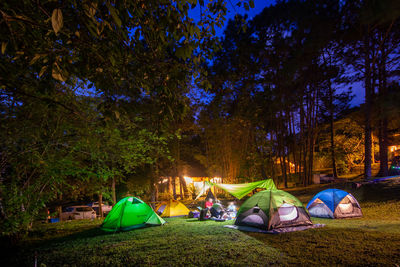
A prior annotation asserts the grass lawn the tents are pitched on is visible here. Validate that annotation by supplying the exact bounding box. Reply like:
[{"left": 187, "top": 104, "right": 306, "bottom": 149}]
[{"left": 1, "top": 181, "right": 400, "bottom": 266}]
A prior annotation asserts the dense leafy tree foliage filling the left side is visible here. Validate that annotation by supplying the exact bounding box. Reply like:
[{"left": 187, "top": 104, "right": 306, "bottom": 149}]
[{"left": 0, "top": 0, "right": 242, "bottom": 239}]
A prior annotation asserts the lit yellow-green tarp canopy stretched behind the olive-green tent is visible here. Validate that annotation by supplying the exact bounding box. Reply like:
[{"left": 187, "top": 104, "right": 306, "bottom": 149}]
[{"left": 196, "top": 179, "right": 276, "bottom": 199}]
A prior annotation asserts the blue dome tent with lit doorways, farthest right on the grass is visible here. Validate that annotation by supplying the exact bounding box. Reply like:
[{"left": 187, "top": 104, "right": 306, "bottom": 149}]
[{"left": 307, "top": 189, "right": 362, "bottom": 218}]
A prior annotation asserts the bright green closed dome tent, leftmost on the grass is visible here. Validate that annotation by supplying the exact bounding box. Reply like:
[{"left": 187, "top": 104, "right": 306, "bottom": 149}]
[{"left": 101, "top": 197, "right": 165, "bottom": 231}]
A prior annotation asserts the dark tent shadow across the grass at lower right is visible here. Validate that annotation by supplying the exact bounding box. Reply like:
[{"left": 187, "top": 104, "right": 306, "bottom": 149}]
[{"left": 242, "top": 224, "right": 400, "bottom": 266}]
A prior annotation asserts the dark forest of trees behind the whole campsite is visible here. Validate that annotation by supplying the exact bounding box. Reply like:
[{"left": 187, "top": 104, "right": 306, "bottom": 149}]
[{"left": 0, "top": 0, "right": 400, "bottom": 239}]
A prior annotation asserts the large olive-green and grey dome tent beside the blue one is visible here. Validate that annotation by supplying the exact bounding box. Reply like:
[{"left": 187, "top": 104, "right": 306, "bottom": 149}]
[{"left": 235, "top": 190, "right": 312, "bottom": 230}]
